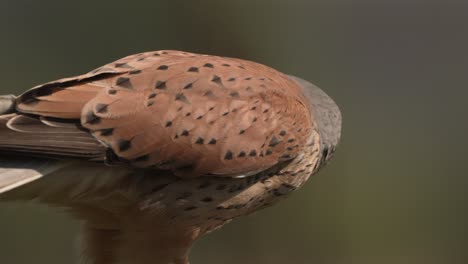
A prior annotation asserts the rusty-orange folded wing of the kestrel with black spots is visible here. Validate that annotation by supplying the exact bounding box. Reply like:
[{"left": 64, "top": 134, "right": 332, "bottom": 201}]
[{"left": 8, "top": 51, "right": 314, "bottom": 177}]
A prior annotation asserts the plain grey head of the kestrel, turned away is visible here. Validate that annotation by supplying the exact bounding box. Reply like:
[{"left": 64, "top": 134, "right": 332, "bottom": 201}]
[{"left": 289, "top": 75, "right": 341, "bottom": 167}]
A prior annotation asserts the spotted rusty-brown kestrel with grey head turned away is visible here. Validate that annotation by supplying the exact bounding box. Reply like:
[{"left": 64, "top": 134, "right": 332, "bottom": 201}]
[{"left": 0, "top": 50, "right": 342, "bottom": 264}]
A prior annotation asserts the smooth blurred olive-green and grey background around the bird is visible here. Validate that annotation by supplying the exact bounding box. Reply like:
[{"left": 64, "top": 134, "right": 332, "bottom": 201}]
[{"left": 0, "top": 0, "right": 468, "bottom": 264}]
